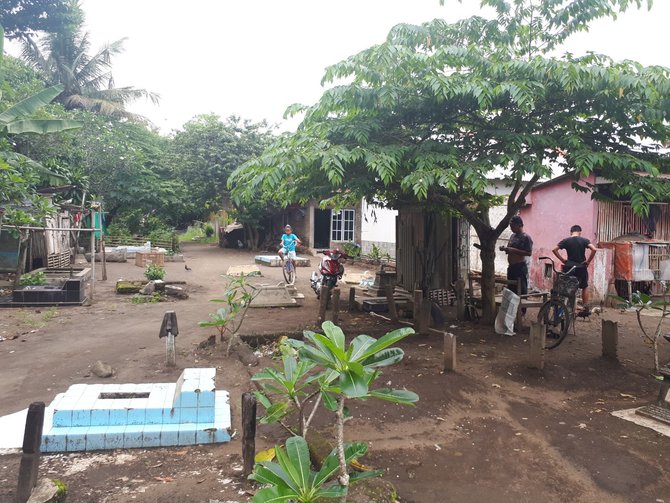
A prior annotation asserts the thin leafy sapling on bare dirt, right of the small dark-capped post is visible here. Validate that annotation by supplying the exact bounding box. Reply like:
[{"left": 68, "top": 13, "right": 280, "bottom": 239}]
[{"left": 198, "top": 274, "right": 260, "bottom": 354}]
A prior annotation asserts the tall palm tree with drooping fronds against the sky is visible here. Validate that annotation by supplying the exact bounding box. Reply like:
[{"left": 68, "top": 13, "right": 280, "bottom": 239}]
[{"left": 22, "top": 2, "right": 159, "bottom": 116}]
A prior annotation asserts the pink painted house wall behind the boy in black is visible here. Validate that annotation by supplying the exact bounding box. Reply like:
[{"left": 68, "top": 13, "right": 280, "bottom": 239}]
[{"left": 519, "top": 178, "right": 597, "bottom": 290}]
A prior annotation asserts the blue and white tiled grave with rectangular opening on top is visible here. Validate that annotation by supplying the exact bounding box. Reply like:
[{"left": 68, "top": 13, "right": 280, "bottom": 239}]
[{"left": 42, "top": 368, "right": 230, "bottom": 452}]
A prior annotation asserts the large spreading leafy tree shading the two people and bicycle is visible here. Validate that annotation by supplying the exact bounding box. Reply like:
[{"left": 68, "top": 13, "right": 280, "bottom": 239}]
[{"left": 231, "top": 0, "right": 670, "bottom": 321}]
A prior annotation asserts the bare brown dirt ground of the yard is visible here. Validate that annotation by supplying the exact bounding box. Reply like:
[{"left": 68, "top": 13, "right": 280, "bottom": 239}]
[{"left": 0, "top": 245, "right": 670, "bottom": 503}]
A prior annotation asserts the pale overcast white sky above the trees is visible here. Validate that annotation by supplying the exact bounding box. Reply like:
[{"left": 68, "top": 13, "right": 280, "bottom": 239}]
[{"left": 9, "top": 0, "right": 670, "bottom": 132}]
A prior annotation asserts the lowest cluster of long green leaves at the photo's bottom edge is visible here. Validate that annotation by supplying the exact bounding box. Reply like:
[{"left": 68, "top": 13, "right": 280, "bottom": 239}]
[{"left": 249, "top": 437, "right": 383, "bottom": 503}]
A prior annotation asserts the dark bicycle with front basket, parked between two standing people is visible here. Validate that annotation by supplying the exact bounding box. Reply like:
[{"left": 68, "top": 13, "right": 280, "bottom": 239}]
[{"left": 537, "top": 257, "right": 579, "bottom": 349}]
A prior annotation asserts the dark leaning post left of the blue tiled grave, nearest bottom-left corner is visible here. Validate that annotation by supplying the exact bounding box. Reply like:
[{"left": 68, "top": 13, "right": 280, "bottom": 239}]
[{"left": 16, "top": 402, "right": 44, "bottom": 503}]
